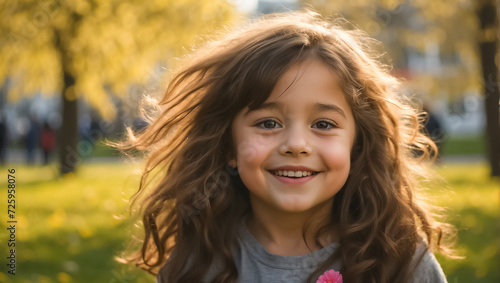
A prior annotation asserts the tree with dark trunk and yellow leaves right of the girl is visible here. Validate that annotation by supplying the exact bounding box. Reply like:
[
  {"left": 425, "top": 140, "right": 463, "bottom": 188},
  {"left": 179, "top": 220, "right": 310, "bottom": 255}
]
[{"left": 302, "top": 0, "right": 500, "bottom": 176}]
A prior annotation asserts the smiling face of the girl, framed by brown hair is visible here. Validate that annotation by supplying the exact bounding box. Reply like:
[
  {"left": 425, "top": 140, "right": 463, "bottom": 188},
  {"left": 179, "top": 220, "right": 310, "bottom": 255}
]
[{"left": 230, "top": 60, "right": 355, "bottom": 215}]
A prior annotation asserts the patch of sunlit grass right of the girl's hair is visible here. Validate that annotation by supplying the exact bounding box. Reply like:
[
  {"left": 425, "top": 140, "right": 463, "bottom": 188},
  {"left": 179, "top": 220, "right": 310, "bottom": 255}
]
[{"left": 430, "top": 164, "right": 500, "bottom": 283}]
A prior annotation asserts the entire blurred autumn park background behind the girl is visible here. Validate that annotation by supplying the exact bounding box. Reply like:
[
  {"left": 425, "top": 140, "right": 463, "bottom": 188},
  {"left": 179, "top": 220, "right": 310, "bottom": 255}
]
[{"left": 0, "top": 0, "right": 500, "bottom": 283}]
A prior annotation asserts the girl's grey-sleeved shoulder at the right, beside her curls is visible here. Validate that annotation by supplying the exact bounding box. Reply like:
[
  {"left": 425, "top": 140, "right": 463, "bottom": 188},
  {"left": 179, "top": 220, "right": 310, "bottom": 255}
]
[{"left": 410, "top": 242, "right": 447, "bottom": 283}]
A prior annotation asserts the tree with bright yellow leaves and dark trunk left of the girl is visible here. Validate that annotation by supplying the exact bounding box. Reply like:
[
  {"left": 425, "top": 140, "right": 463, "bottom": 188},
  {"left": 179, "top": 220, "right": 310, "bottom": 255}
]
[{"left": 0, "top": 0, "right": 234, "bottom": 174}]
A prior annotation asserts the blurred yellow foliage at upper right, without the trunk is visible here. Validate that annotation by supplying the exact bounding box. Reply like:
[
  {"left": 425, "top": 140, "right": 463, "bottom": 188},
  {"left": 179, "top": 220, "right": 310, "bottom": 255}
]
[{"left": 302, "top": 0, "right": 486, "bottom": 96}]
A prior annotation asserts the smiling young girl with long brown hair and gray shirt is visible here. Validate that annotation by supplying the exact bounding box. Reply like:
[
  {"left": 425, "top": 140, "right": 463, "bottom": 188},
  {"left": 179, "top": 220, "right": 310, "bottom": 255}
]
[{"left": 121, "top": 11, "right": 454, "bottom": 282}]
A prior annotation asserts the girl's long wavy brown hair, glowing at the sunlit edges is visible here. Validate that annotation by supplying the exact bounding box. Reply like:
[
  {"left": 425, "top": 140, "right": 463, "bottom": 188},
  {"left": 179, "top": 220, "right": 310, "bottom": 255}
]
[{"left": 120, "top": 10, "right": 456, "bottom": 282}]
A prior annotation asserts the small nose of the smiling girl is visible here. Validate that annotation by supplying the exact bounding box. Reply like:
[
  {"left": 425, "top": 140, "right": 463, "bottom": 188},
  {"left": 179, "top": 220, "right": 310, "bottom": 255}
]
[{"left": 279, "top": 125, "right": 312, "bottom": 157}]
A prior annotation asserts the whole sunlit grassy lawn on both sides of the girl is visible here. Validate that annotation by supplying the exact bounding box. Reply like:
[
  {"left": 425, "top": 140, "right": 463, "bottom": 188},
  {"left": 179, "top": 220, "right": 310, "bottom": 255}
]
[{"left": 0, "top": 163, "right": 500, "bottom": 283}]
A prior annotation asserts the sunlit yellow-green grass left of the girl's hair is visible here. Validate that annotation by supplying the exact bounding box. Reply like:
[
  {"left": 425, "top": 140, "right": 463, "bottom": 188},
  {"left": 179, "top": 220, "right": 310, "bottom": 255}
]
[{"left": 0, "top": 163, "right": 155, "bottom": 283}]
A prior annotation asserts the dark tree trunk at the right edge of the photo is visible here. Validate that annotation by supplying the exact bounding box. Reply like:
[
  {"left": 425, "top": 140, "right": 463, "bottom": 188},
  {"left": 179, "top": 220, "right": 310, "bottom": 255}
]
[{"left": 477, "top": 0, "right": 500, "bottom": 176}]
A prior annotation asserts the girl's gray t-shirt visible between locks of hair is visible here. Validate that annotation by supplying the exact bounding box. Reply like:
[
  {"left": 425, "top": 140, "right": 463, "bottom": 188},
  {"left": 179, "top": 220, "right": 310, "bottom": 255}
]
[{"left": 158, "top": 222, "right": 446, "bottom": 283}]
